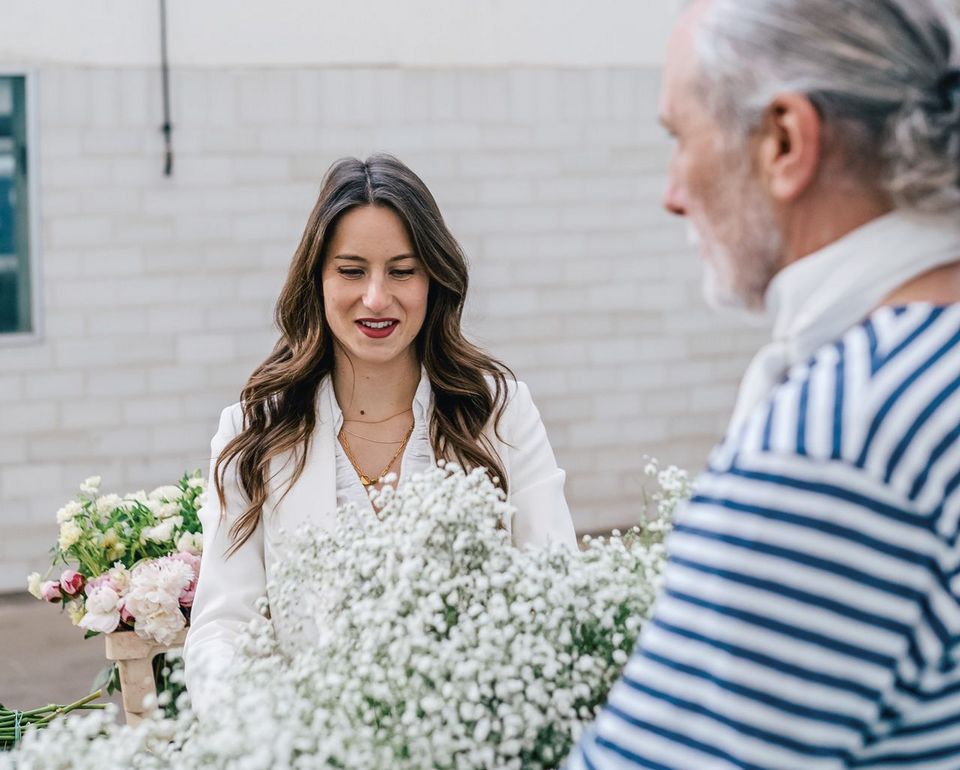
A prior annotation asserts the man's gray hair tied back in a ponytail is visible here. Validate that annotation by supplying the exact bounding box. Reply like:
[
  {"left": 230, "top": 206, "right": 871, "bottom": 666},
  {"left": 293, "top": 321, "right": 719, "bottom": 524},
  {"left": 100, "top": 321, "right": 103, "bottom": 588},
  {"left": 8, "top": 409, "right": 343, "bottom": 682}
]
[{"left": 697, "top": 0, "right": 960, "bottom": 210}]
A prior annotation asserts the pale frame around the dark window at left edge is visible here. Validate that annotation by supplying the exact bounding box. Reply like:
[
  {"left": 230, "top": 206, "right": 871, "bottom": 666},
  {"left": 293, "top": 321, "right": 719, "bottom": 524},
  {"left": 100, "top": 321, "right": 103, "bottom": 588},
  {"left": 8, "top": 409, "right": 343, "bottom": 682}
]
[{"left": 0, "top": 64, "right": 44, "bottom": 348}]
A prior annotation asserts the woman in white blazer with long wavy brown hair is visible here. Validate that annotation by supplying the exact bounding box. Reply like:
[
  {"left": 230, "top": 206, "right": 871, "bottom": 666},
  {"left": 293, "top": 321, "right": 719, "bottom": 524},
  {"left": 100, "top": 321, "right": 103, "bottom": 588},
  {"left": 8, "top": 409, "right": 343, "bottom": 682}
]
[{"left": 184, "top": 155, "right": 576, "bottom": 711}]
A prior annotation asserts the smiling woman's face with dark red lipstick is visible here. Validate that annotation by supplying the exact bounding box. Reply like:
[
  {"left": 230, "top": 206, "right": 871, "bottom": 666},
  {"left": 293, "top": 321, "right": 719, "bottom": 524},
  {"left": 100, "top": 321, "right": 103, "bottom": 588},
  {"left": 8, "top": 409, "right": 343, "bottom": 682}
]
[{"left": 321, "top": 206, "right": 430, "bottom": 364}]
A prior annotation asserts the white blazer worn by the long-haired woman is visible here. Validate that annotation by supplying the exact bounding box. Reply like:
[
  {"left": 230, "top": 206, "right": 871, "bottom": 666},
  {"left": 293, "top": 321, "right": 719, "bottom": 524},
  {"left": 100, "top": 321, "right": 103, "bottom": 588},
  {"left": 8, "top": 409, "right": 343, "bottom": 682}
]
[{"left": 184, "top": 381, "right": 576, "bottom": 714}]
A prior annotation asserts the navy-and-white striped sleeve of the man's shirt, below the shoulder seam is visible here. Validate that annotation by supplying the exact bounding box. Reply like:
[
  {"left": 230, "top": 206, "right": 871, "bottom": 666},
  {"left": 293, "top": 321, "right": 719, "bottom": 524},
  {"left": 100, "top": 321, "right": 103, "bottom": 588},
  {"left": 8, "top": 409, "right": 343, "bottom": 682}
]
[{"left": 568, "top": 448, "right": 955, "bottom": 770}]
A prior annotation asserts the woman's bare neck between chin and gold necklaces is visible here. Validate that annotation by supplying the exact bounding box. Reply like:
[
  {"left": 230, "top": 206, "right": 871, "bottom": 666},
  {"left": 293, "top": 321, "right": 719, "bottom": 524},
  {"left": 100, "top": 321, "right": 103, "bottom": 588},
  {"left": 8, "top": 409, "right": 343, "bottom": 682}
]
[{"left": 333, "top": 350, "right": 420, "bottom": 422}]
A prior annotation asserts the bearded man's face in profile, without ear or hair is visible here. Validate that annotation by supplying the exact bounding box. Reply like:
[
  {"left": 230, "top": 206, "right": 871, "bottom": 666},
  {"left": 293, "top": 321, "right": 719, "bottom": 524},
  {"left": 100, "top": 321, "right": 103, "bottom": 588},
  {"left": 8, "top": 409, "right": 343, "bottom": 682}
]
[{"left": 660, "top": 2, "right": 783, "bottom": 309}]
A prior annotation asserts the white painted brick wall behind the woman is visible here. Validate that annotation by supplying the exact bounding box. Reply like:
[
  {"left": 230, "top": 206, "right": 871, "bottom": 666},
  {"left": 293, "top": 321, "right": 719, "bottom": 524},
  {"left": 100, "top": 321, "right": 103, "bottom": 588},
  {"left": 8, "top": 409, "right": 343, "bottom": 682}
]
[{"left": 0, "top": 66, "right": 763, "bottom": 591}]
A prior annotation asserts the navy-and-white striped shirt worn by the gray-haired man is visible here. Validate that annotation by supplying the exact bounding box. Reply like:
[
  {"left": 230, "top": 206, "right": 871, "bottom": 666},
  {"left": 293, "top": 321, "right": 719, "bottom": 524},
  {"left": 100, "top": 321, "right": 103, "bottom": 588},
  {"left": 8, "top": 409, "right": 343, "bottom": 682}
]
[{"left": 569, "top": 304, "right": 960, "bottom": 770}]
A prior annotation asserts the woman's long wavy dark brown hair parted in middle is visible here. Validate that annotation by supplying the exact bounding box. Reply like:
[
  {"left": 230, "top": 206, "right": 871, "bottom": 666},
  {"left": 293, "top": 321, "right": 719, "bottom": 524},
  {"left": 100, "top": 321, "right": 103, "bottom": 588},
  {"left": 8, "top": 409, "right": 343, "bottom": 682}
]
[{"left": 214, "top": 155, "right": 513, "bottom": 553}]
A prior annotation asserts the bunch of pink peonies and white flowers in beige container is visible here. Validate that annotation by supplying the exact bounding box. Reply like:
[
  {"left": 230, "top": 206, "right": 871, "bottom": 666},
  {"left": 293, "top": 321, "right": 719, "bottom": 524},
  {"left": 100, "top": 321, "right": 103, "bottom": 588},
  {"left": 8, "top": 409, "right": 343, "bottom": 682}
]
[{"left": 27, "top": 474, "right": 204, "bottom": 644}]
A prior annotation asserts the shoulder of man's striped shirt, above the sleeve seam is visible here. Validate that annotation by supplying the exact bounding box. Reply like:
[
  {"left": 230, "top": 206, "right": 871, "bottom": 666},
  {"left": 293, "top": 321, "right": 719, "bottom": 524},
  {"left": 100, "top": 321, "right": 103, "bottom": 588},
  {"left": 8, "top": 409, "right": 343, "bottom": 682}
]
[{"left": 722, "top": 304, "right": 960, "bottom": 508}]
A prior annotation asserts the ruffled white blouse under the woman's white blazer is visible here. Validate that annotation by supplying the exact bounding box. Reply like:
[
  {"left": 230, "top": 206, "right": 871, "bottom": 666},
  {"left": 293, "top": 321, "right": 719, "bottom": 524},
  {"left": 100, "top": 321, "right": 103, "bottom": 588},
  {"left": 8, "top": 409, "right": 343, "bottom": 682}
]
[{"left": 332, "top": 368, "right": 433, "bottom": 509}]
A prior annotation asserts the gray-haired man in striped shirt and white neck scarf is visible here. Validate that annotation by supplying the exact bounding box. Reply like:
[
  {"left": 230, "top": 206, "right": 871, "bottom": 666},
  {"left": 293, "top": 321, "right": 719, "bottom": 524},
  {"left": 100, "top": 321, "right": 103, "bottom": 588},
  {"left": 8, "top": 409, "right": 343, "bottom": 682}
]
[{"left": 569, "top": 0, "right": 960, "bottom": 770}]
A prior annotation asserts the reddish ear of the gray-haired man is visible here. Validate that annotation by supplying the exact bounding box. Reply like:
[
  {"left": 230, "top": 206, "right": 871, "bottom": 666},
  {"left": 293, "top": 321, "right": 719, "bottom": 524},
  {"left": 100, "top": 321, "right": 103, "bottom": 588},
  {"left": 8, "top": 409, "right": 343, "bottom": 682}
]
[{"left": 757, "top": 93, "right": 823, "bottom": 203}]
